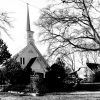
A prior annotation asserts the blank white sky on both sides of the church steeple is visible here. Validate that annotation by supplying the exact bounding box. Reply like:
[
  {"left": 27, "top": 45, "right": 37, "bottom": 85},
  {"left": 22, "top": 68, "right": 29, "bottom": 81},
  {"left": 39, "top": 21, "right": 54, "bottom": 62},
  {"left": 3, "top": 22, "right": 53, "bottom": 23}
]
[{"left": 0, "top": 0, "right": 48, "bottom": 55}]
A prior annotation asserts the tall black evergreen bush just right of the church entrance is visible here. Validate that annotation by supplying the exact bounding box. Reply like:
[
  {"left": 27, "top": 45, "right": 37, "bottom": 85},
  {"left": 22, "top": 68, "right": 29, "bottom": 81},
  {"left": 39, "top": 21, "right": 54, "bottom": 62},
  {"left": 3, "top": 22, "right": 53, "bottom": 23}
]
[{"left": 46, "top": 58, "right": 65, "bottom": 91}]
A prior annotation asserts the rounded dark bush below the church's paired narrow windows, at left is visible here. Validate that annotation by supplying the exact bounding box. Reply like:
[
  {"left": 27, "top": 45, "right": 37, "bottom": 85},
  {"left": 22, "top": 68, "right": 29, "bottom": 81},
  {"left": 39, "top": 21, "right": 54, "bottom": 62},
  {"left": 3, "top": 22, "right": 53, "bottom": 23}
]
[{"left": 3, "top": 59, "right": 22, "bottom": 84}]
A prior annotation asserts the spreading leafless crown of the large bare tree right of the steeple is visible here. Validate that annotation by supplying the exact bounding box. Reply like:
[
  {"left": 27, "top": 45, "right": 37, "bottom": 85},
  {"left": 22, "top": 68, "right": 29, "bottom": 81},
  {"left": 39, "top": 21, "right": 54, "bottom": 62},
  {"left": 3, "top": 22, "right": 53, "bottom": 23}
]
[{"left": 37, "top": 0, "right": 100, "bottom": 63}]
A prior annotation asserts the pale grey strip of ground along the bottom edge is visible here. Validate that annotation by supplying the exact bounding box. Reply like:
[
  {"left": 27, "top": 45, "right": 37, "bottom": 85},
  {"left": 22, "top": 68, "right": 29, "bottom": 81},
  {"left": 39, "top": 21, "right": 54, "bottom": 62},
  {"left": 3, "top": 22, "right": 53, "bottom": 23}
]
[{"left": 0, "top": 91, "right": 100, "bottom": 100}]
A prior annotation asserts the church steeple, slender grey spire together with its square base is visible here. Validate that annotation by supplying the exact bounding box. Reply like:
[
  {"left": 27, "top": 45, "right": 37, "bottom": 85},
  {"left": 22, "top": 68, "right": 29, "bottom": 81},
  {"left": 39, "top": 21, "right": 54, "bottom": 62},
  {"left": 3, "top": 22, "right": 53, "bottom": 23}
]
[{"left": 26, "top": 3, "right": 34, "bottom": 45}]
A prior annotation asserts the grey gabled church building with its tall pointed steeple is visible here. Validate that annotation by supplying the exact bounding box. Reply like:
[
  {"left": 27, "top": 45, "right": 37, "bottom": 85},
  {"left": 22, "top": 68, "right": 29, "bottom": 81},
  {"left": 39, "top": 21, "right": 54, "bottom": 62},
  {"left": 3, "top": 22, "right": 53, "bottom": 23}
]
[{"left": 14, "top": 4, "right": 49, "bottom": 77}]
